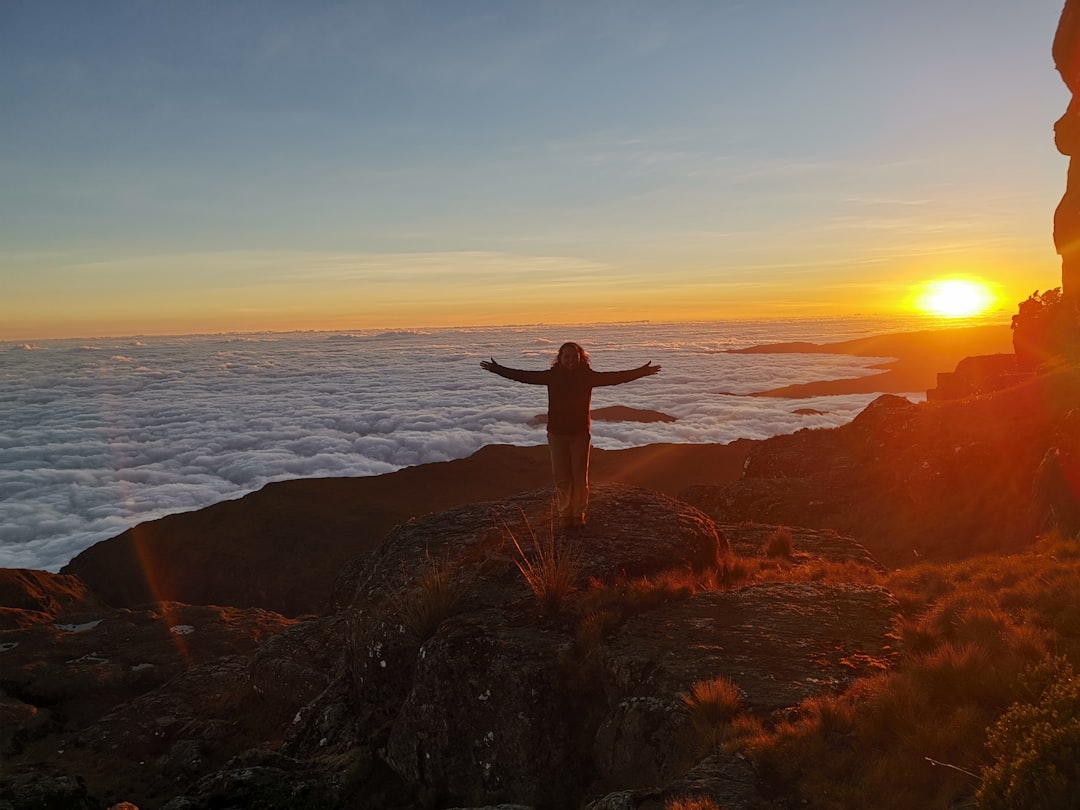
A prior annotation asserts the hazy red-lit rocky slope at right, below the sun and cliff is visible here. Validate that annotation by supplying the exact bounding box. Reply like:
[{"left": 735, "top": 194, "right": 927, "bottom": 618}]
[{"left": 681, "top": 369, "right": 1080, "bottom": 566}]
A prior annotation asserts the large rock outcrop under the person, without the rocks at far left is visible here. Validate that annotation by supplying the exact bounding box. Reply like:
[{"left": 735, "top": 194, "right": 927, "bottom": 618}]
[{"left": 288, "top": 487, "right": 896, "bottom": 807}]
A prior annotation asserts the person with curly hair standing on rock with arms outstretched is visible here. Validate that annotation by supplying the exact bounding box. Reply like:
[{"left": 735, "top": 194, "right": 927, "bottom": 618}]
[{"left": 480, "top": 343, "right": 660, "bottom": 528}]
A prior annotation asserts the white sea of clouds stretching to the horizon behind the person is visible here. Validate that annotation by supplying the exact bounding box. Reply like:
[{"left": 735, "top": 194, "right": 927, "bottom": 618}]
[{"left": 0, "top": 320, "right": 937, "bottom": 571}]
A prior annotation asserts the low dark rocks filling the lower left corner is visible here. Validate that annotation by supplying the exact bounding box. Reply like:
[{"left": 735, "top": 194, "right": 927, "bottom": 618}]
[{"left": 0, "top": 591, "right": 312, "bottom": 807}]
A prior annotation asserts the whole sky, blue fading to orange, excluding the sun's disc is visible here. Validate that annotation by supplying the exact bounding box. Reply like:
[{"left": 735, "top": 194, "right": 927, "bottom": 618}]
[{"left": 0, "top": 0, "right": 1068, "bottom": 340}]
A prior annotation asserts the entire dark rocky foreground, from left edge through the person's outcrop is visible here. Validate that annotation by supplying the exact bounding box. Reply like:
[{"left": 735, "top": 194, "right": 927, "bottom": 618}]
[{"left": 0, "top": 485, "right": 896, "bottom": 810}]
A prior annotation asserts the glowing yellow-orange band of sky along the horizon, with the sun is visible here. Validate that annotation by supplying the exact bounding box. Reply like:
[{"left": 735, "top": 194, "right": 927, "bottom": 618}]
[{"left": 8, "top": 259, "right": 1058, "bottom": 341}]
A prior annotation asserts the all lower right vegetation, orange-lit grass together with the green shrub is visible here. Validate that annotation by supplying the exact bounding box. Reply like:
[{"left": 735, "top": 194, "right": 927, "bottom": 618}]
[{"left": 725, "top": 553, "right": 1080, "bottom": 810}]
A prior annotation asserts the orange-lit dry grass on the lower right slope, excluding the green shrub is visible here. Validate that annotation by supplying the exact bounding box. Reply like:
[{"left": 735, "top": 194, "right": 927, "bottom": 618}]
[{"left": 725, "top": 543, "right": 1080, "bottom": 810}]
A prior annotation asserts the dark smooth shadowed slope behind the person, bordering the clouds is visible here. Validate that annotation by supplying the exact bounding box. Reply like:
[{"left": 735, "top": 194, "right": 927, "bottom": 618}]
[{"left": 63, "top": 440, "right": 757, "bottom": 616}]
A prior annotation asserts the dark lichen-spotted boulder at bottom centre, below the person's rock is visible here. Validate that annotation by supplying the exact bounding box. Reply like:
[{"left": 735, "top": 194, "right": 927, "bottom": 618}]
[{"left": 386, "top": 613, "right": 590, "bottom": 807}]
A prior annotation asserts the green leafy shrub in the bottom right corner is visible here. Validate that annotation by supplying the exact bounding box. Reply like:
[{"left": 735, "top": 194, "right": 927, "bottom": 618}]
[{"left": 975, "top": 657, "right": 1080, "bottom": 810}]
